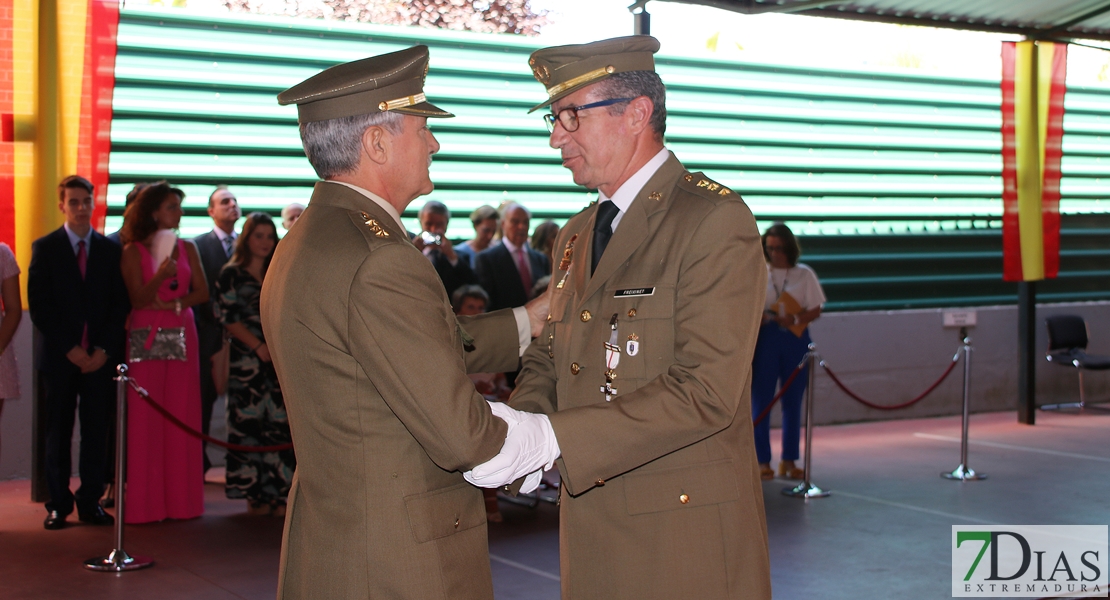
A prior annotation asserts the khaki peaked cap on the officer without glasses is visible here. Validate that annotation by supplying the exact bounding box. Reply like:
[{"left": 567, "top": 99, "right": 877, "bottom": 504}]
[{"left": 278, "top": 45, "right": 454, "bottom": 123}]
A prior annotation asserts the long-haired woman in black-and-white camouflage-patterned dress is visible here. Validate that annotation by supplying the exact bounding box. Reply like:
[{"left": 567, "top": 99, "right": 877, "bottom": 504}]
[{"left": 216, "top": 213, "right": 296, "bottom": 517}]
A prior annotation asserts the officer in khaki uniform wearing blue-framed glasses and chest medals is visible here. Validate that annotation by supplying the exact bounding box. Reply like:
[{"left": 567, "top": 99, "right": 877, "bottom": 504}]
[{"left": 467, "top": 35, "right": 770, "bottom": 600}]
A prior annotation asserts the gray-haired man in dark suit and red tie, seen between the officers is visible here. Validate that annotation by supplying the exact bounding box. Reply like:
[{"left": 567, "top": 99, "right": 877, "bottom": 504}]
[{"left": 477, "top": 202, "right": 552, "bottom": 311}]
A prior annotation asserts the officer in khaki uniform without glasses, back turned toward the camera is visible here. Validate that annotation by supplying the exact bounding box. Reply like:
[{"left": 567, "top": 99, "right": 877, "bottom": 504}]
[{"left": 261, "top": 45, "right": 547, "bottom": 600}]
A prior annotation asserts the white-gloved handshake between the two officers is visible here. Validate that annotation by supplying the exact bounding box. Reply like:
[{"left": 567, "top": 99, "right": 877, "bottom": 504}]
[{"left": 463, "top": 403, "right": 561, "bottom": 494}]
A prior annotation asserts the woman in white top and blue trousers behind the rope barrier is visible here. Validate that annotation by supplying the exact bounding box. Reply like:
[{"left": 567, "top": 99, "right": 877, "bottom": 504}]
[{"left": 751, "top": 223, "right": 825, "bottom": 480}]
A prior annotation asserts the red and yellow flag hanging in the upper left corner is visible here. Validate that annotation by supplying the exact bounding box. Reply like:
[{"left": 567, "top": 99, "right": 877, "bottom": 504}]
[{"left": 0, "top": 0, "right": 120, "bottom": 290}]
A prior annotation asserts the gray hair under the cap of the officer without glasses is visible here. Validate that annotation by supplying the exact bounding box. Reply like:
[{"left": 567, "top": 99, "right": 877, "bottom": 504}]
[{"left": 301, "top": 111, "right": 404, "bottom": 180}]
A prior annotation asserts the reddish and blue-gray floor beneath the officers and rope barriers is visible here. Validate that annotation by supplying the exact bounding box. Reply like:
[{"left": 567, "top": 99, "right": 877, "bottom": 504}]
[{"left": 0, "top": 411, "right": 1110, "bottom": 600}]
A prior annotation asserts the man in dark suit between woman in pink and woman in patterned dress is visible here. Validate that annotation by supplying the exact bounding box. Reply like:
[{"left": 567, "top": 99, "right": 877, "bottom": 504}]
[{"left": 193, "top": 185, "right": 242, "bottom": 470}]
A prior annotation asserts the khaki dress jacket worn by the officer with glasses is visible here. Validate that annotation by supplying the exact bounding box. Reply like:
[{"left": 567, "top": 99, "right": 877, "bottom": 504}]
[{"left": 511, "top": 155, "right": 770, "bottom": 600}]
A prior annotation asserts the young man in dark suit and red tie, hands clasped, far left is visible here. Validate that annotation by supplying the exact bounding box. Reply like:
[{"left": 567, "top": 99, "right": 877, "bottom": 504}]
[{"left": 27, "top": 175, "right": 131, "bottom": 529}]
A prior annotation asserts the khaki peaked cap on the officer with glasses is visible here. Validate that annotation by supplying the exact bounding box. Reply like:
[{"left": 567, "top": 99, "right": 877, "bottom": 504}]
[{"left": 528, "top": 35, "right": 659, "bottom": 112}]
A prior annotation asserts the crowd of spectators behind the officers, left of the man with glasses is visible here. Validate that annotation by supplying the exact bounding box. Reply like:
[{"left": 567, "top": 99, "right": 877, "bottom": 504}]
[{"left": 13, "top": 175, "right": 558, "bottom": 529}]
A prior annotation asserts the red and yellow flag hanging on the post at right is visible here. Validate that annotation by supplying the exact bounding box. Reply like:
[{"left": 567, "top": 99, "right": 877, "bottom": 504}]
[{"left": 1002, "top": 41, "right": 1068, "bottom": 282}]
